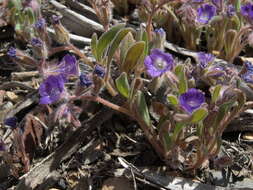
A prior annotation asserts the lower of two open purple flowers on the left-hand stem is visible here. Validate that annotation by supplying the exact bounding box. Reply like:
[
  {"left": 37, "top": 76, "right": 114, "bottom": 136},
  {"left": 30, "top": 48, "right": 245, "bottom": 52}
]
[{"left": 39, "top": 75, "right": 65, "bottom": 104}]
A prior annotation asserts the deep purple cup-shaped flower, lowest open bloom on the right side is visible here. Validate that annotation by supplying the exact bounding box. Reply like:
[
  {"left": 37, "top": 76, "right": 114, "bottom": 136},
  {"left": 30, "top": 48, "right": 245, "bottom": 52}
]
[{"left": 179, "top": 88, "right": 205, "bottom": 113}]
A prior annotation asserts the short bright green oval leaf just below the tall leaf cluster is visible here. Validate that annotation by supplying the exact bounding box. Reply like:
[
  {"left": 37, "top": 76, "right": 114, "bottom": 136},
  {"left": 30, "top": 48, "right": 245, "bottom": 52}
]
[{"left": 115, "top": 72, "right": 130, "bottom": 98}]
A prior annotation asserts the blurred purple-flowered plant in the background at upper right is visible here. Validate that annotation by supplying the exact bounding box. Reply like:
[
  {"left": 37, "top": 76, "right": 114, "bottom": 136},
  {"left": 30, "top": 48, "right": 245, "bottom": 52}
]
[{"left": 139, "top": 0, "right": 253, "bottom": 63}]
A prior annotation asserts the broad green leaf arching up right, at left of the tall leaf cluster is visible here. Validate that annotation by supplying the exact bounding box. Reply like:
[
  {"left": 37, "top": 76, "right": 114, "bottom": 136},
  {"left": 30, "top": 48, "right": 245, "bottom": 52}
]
[{"left": 97, "top": 24, "right": 125, "bottom": 61}]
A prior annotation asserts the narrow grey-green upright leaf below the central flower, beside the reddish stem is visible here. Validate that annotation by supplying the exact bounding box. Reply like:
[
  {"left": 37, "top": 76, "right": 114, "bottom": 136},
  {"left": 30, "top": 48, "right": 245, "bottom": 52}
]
[{"left": 136, "top": 90, "right": 151, "bottom": 126}]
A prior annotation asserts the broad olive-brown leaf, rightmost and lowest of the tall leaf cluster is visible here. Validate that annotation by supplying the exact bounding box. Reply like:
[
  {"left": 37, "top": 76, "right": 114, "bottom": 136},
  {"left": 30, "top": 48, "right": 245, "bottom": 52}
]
[{"left": 122, "top": 41, "right": 145, "bottom": 73}]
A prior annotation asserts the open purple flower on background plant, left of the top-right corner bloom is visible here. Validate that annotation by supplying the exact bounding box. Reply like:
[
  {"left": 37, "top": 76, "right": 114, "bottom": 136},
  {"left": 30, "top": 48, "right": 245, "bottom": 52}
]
[{"left": 197, "top": 4, "right": 216, "bottom": 24}]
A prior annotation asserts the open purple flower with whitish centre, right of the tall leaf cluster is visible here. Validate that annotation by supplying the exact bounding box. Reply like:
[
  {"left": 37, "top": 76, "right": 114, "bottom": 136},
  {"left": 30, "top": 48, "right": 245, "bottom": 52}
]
[{"left": 144, "top": 49, "right": 174, "bottom": 77}]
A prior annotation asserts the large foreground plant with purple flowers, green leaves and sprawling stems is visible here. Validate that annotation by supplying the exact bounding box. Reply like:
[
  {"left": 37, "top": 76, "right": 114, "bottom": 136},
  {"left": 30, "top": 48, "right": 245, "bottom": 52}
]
[{"left": 0, "top": 1, "right": 253, "bottom": 174}]
